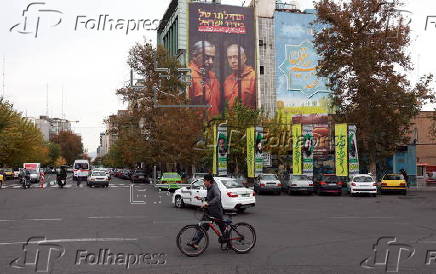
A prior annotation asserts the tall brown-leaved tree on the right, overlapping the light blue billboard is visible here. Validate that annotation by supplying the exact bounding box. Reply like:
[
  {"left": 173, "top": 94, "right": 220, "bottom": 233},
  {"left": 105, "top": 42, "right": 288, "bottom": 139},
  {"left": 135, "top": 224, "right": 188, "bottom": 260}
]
[{"left": 314, "top": 0, "right": 435, "bottom": 174}]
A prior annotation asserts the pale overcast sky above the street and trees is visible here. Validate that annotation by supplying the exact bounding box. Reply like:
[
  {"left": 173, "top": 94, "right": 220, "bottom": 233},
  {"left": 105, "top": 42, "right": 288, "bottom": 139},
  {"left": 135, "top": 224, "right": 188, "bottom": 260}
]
[{"left": 0, "top": 0, "right": 436, "bottom": 152}]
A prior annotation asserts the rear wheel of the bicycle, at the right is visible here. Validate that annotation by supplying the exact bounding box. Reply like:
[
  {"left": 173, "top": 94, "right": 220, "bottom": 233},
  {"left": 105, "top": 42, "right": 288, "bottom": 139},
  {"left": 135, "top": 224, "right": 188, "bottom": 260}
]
[{"left": 229, "top": 223, "right": 256, "bottom": 254}]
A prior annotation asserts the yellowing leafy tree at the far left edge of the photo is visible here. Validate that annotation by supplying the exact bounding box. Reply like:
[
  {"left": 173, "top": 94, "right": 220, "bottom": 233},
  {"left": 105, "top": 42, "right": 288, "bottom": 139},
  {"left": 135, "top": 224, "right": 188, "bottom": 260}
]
[{"left": 0, "top": 98, "right": 48, "bottom": 167}]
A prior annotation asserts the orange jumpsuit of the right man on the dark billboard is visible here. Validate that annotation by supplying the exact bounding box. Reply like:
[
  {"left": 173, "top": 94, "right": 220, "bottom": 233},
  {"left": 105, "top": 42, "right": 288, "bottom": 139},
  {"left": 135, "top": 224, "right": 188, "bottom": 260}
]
[{"left": 224, "top": 66, "right": 256, "bottom": 108}]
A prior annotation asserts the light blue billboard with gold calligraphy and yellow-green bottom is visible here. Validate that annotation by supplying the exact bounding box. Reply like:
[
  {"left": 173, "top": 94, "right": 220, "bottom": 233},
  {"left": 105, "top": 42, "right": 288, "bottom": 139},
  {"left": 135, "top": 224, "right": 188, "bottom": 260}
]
[{"left": 274, "top": 11, "right": 331, "bottom": 123}]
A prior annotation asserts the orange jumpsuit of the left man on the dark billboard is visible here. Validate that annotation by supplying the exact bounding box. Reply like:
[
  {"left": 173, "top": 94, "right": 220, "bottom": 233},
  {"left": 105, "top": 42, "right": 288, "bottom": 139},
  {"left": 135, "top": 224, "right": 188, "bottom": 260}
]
[{"left": 189, "top": 62, "right": 221, "bottom": 116}]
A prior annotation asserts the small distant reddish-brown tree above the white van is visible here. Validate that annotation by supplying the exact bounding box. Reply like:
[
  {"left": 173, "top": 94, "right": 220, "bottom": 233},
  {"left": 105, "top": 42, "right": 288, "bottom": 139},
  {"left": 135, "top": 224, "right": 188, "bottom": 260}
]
[{"left": 51, "top": 131, "right": 83, "bottom": 165}]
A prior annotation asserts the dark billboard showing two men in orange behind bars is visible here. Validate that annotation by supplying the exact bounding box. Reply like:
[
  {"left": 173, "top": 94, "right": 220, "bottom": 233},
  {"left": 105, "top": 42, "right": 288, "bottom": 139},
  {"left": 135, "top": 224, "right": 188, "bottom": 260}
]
[{"left": 188, "top": 3, "right": 256, "bottom": 117}]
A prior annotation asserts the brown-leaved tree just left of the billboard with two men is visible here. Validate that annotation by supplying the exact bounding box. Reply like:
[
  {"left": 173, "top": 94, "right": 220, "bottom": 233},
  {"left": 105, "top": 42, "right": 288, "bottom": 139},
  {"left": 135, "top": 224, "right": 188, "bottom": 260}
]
[{"left": 107, "top": 43, "right": 204, "bottom": 168}]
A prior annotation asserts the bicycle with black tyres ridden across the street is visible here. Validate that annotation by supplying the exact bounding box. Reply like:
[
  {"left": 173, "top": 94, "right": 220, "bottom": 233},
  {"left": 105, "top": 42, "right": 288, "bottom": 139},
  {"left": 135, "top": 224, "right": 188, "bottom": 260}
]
[{"left": 177, "top": 210, "right": 256, "bottom": 257}]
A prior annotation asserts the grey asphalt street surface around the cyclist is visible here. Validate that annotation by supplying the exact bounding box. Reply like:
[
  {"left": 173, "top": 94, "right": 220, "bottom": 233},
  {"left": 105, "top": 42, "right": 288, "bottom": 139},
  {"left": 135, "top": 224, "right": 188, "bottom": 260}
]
[{"left": 0, "top": 176, "right": 436, "bottom": 273}]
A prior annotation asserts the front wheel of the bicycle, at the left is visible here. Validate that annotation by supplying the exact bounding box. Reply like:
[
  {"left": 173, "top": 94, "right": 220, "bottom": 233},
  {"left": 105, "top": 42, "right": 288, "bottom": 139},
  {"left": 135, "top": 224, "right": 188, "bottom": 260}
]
[{"left": 177, "top": 225, "right": 209, "bottom": 257}]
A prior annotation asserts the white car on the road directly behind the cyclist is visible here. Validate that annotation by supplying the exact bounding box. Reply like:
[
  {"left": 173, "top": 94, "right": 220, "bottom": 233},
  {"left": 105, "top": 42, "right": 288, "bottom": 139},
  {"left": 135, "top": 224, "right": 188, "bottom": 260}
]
[{"left": 172, "top": 177, "right": 256, "bottom": 213}]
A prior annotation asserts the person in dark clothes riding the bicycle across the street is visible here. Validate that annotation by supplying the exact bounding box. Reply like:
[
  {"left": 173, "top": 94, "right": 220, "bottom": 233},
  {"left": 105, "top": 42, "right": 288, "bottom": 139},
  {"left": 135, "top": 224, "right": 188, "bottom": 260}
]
[{"left": 187, "top": 174, "right": 227, "bottom": 249}]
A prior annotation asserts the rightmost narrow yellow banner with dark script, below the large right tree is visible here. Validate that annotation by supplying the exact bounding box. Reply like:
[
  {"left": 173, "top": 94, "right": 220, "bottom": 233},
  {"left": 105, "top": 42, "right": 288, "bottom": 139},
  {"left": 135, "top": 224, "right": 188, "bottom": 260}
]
[{"left": 335, "top": 124, "right": 348, "bottom": 176}]
